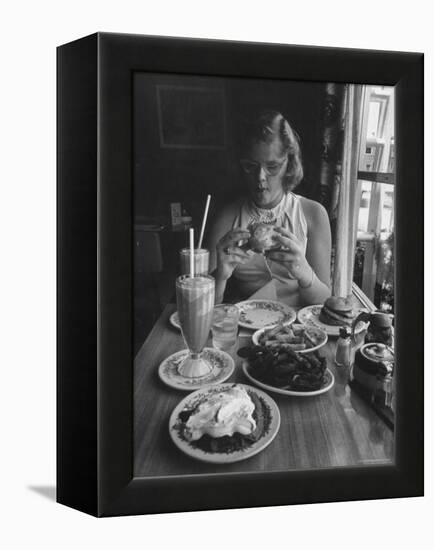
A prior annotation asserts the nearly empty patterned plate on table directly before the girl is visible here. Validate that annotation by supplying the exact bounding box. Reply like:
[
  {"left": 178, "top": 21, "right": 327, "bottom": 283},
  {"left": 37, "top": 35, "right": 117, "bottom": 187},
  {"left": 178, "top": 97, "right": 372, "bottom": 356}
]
[{"left": 236, "top": 300, "right": 297, "bottom": 330}]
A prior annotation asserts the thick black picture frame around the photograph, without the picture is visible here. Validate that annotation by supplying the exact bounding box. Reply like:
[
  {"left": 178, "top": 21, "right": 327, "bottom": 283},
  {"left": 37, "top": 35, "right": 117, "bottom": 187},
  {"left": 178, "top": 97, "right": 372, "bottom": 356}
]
[{"left": 57, "top": 33, "right": 424, "bottom": 516}]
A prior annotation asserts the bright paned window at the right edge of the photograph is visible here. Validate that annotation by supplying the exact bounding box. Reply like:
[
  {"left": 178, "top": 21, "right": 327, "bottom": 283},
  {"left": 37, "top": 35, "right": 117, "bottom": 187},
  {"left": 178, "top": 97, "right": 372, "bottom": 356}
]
[{"left": 354, "top": 86, "right": 395, "bottom": 312}]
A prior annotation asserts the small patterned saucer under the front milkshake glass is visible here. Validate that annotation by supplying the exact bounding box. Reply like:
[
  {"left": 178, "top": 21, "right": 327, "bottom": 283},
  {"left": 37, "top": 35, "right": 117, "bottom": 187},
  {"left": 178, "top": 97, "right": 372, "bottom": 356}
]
[{"left": 158, "top": 348, "right": 235, "bottom": 391}]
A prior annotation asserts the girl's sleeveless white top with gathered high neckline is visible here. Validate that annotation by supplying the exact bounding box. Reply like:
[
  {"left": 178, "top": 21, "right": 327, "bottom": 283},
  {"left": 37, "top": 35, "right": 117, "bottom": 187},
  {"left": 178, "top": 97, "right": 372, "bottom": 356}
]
[{"left": 232, "top": 192, "right": 307, "bottom": 306}]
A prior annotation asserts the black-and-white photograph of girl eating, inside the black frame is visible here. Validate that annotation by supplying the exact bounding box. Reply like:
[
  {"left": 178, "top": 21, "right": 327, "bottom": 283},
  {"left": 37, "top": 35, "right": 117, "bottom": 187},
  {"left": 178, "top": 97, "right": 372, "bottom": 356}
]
[{"left": 133, "top": 71, "right": 397, "bottom": 477}]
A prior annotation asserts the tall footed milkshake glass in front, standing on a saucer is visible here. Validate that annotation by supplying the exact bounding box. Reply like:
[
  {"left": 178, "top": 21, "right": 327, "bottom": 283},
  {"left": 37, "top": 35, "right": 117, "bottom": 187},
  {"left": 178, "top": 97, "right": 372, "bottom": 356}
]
[{"left": 176, "top": 275, "right": 215, "bottom": 378}]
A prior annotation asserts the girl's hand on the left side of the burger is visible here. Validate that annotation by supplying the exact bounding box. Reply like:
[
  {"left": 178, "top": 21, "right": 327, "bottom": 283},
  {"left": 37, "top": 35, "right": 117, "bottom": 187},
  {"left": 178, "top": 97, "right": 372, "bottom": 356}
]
[{"left": 216, "top": 229, "right": 251, "bottom": 281}]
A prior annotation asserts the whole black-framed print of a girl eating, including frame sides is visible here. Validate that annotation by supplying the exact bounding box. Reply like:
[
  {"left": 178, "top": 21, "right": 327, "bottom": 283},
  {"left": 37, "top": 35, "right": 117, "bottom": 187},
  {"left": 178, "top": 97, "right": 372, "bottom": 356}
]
[{"left": 57, "top": 33, "right": 423, "bottom": 516}]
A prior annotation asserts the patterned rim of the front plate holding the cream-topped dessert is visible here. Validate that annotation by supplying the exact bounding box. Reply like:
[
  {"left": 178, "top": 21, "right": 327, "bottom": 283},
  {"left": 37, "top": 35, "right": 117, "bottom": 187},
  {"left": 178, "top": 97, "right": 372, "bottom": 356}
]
[{"left": 169, "top": 383, "right": 280, "bottom": 464}]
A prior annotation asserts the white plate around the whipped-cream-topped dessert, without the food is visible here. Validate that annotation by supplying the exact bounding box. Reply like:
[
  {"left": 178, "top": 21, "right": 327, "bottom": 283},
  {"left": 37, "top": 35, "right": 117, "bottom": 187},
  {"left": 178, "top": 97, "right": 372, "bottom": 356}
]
[{"left": 169, "top": 384, "right": 280, "bottom": 464}]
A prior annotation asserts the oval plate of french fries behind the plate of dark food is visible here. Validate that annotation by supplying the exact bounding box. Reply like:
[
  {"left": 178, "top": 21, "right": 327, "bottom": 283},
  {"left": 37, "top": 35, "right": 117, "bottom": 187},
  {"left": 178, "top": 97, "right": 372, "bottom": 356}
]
[{"left": 252, "top": 324, "right": 328, "bottom": 353}]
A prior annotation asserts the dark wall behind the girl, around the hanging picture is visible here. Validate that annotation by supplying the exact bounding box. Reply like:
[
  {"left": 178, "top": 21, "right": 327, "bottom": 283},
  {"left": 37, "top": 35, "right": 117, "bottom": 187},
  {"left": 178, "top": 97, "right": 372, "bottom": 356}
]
[{"left": 133, "top": 73, "right": 325, "bottom": 229}]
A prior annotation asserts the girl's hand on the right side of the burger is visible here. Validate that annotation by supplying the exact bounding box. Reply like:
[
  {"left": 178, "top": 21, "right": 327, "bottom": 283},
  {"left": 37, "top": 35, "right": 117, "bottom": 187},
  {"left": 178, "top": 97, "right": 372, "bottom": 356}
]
[{"left": 266, "top": 227, "right": 312, "bottom": 286}]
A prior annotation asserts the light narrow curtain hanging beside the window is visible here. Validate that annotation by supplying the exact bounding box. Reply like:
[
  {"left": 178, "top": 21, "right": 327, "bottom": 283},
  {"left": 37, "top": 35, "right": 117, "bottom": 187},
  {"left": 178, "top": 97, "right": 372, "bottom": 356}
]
[{"left": 333, "top": 84, "right": 364, "bottom": 296}]
